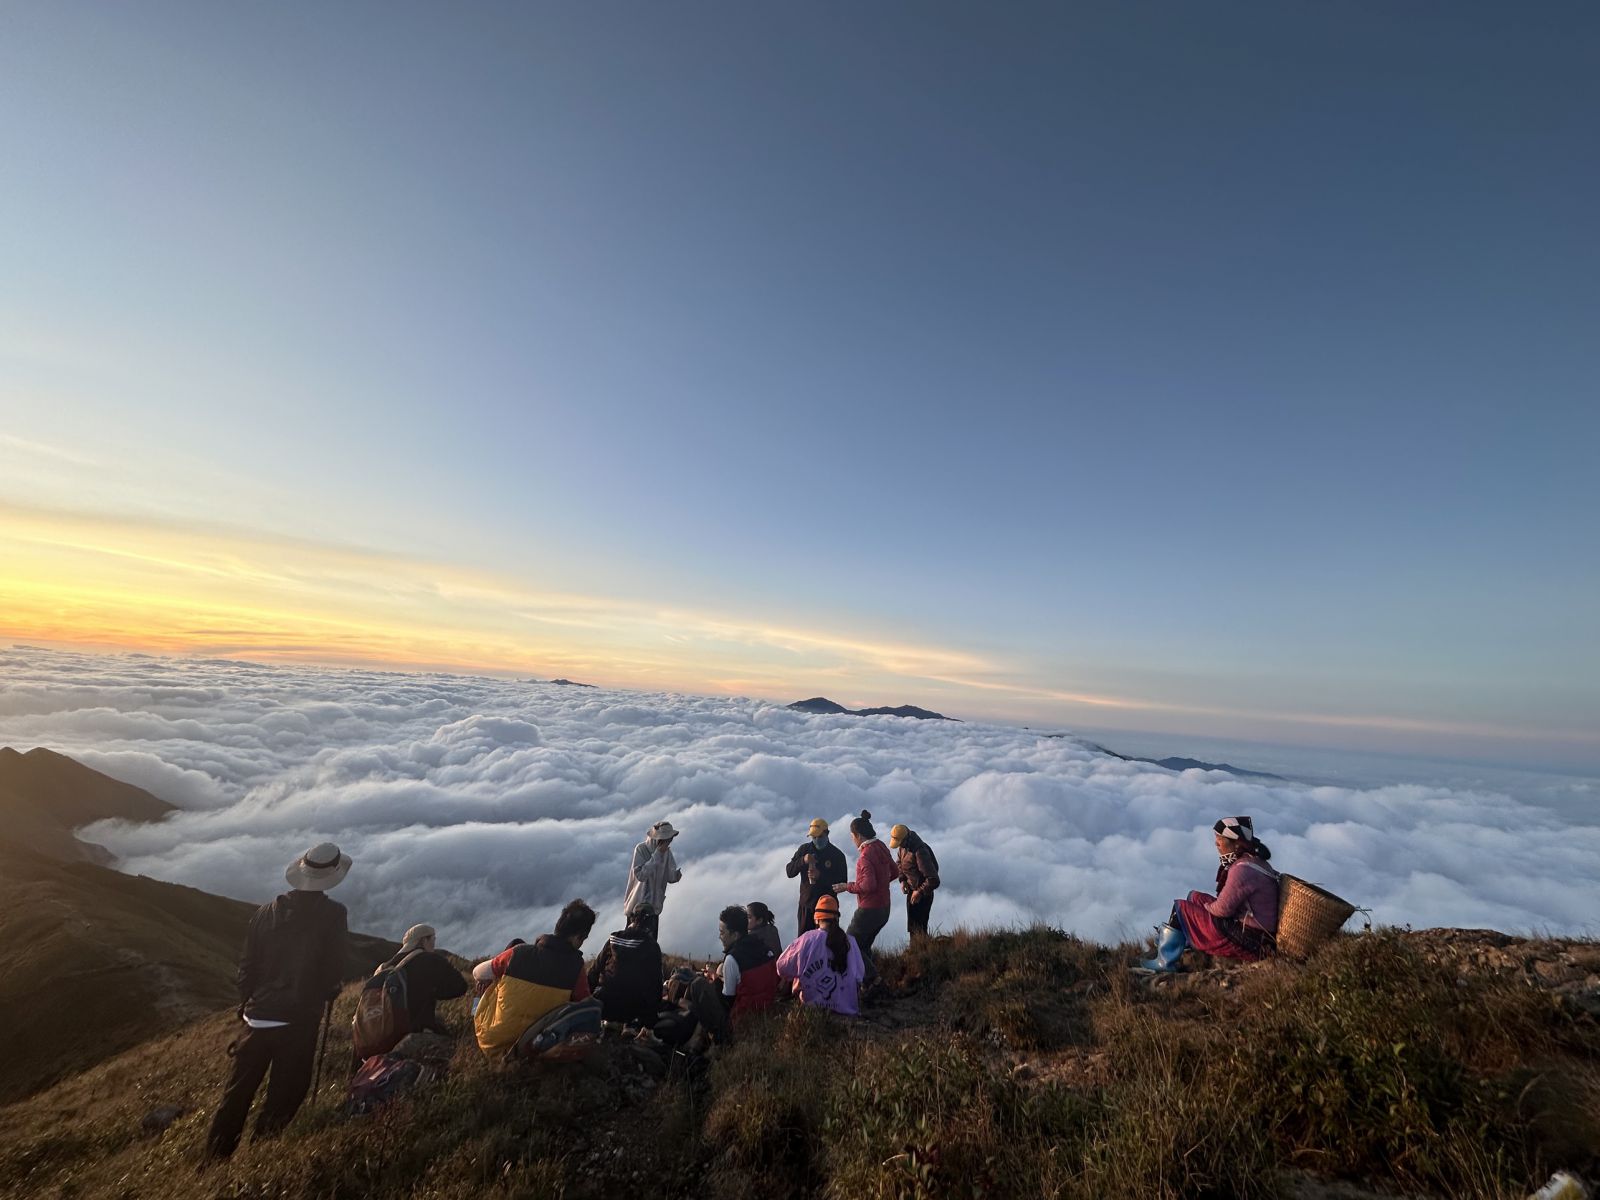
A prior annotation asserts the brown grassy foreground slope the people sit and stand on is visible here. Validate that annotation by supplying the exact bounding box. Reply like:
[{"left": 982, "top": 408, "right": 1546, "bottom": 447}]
[{"left": 0, "top": 930, "right": 1600, "bottom": 1200}]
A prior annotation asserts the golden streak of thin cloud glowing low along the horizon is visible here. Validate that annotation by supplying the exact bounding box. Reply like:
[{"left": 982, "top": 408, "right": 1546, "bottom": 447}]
[{"left": 0, "top": 498, "right": 1600, "bottom": 760}]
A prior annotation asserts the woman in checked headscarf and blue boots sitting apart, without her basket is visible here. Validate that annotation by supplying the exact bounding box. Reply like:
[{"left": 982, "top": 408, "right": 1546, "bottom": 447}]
[{"left": 1136, "top": 816, "right": 1278, "bottom": 971}]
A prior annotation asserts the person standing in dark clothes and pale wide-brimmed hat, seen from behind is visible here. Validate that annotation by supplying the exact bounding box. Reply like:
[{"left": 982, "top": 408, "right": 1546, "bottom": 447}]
[{"left": 206, "top": 842, "right": 350, "bottom": 1158}]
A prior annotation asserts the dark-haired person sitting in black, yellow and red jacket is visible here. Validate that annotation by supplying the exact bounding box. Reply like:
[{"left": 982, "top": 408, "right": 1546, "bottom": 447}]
[{"left": 472, "top": 899, "right": 595, "bottom": 1061}]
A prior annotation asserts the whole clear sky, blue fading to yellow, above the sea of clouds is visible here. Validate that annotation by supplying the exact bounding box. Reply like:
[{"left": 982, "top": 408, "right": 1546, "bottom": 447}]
[{"left": 0, "top": 3, "right": 1600, "bottom": 770}]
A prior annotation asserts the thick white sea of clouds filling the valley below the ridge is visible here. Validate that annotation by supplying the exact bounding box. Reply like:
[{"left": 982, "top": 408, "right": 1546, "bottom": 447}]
[{"left": 0, "top": 646, "right": 1600, "bottom": 955}]
